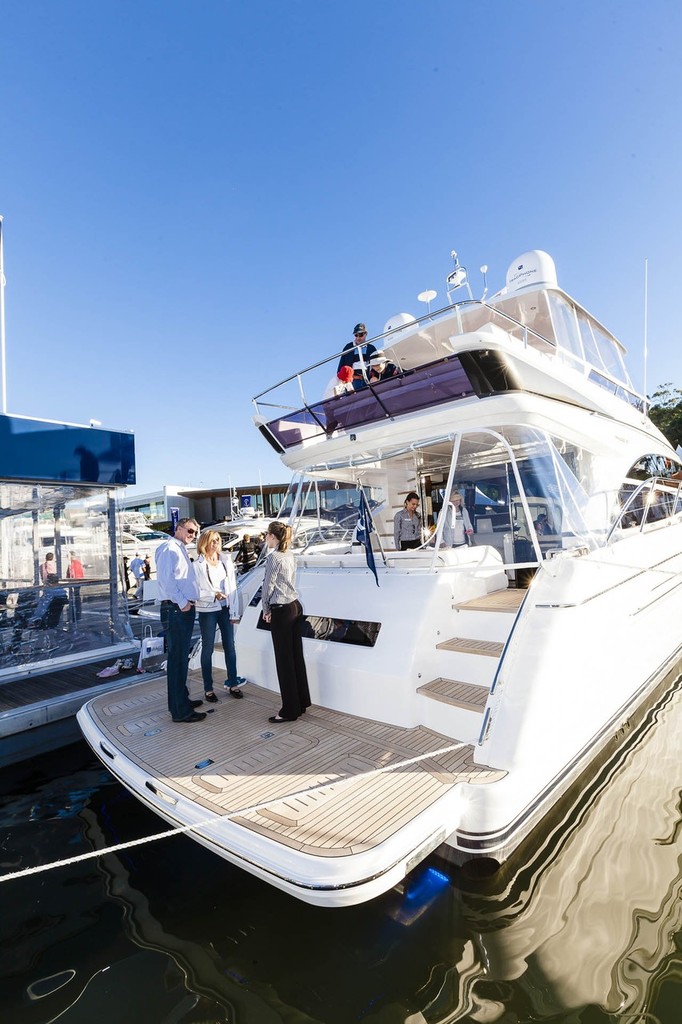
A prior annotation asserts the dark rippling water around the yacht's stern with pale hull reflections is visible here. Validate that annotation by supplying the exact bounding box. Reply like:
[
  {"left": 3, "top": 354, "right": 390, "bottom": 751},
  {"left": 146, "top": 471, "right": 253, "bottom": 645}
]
[{"left": 0, "top": 690, "right": 682, "bottom": 1024}]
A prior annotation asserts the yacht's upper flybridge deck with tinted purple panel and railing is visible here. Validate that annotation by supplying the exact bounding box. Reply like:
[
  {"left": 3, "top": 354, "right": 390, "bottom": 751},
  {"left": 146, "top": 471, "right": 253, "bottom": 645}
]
[{"left": 254, "top": 278, "right": 644, "bottom": 454}]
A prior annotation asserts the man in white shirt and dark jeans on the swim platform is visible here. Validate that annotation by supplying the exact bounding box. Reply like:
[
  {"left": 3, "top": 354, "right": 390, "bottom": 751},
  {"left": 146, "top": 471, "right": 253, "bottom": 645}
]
[{"left": 155, "top": 519, "right": 206, "bottom": 722}]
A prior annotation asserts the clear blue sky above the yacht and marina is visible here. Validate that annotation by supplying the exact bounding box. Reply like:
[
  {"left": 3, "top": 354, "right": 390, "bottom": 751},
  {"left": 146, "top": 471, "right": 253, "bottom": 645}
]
[{"left": 0, "top": 0, "right": 682, "bottom": 490}]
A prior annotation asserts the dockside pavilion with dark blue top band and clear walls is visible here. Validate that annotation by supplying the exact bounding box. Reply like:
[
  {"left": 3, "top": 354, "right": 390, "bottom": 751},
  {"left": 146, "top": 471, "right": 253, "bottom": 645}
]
[{"left": 0, "top": 416, "right": 135, "bottom": 682}]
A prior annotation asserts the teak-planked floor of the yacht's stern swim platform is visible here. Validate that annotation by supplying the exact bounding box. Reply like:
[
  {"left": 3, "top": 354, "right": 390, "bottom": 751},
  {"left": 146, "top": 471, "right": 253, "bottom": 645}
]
[{"left": 84, "top": 673, "right": 504, "bottom": 857}]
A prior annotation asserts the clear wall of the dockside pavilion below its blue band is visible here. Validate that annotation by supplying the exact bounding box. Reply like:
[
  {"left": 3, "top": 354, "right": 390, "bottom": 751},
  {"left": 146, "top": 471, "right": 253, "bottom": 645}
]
[{"left": 0, "top": 483, "right": 132, "bottom": 680}]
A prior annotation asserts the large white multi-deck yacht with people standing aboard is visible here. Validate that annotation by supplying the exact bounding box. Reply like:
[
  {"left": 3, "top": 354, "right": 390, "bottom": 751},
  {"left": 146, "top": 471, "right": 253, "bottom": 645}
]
[{"left": 79, "top": 251, "right": 682, "bottom": 906}]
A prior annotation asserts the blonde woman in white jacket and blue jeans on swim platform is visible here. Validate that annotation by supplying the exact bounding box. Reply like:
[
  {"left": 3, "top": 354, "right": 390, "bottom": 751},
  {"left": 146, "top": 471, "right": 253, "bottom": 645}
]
[{"left": 194, "top": 529, "right": 246, "bottom": 703}]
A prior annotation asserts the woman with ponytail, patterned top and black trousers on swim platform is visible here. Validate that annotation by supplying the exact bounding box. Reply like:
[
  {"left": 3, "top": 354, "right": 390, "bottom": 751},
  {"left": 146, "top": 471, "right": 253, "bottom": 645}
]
[{"left": 262, "top": 520, "right": 310, "bottom": 723}]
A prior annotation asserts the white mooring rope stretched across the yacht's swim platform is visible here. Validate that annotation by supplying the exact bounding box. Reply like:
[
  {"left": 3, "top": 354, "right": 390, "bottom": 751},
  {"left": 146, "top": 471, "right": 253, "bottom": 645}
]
[{"left": 0, "top": 742, "right": 468, "bottom": 882}]
